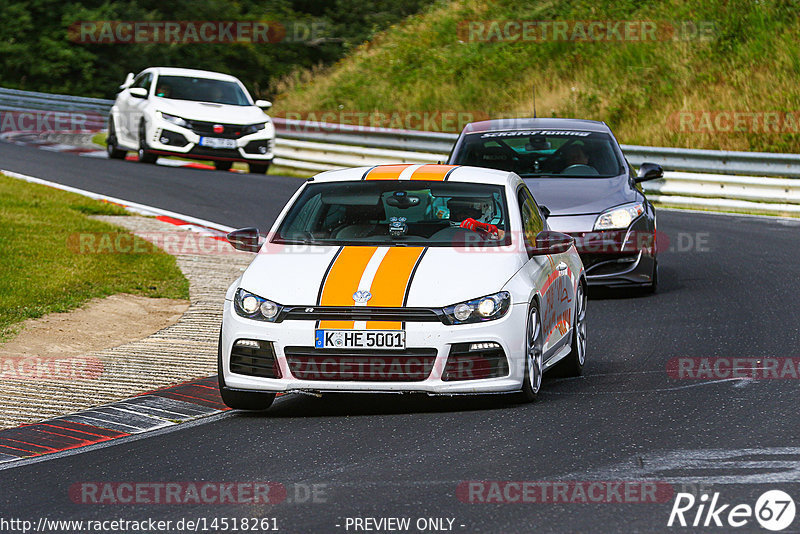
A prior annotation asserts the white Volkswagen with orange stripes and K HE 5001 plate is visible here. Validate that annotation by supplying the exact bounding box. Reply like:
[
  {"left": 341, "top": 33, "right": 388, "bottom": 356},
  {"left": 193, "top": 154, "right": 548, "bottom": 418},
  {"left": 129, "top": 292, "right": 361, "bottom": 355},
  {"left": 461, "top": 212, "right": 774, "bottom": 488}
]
[{"left": 219, "top": 165, "right": 586, "bottom": 410}]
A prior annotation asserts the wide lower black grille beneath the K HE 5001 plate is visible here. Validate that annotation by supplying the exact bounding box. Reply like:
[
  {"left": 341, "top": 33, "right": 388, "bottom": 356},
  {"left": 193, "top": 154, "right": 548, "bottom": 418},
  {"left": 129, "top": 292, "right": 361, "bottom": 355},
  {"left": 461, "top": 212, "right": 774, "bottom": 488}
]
[{"left": 284, "top": 347, "right": 436, "bottom": 382}]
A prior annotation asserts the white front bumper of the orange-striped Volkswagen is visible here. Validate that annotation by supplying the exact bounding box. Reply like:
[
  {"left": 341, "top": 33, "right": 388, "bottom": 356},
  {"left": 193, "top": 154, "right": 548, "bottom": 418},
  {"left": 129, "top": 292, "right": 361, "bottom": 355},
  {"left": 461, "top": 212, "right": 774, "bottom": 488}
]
[{"left": 220, "top": 300, "right": 527, "bottom": 395}]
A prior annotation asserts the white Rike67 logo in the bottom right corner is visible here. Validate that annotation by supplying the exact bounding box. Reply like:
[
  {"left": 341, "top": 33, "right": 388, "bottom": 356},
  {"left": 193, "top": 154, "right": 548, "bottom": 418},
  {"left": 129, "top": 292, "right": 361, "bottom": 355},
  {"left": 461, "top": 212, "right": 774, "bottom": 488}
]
[{"left": 667, "top": 490, "right": 795, "bottom": 531}]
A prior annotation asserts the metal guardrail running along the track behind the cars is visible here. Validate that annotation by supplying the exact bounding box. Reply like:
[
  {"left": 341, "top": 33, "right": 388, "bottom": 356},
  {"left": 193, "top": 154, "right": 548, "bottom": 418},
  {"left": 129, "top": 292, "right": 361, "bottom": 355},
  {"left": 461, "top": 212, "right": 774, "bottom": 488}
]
[{"left": 6, "top": 88, "right": 800, "bottom": 213}]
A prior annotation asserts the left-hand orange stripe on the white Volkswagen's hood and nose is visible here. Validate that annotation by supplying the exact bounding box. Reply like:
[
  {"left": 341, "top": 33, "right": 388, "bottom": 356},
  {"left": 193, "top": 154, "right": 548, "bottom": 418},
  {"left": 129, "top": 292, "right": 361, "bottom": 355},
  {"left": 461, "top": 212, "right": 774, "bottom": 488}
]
[{"left": 319, "top": 246, "right": 378, "bottom": 329}]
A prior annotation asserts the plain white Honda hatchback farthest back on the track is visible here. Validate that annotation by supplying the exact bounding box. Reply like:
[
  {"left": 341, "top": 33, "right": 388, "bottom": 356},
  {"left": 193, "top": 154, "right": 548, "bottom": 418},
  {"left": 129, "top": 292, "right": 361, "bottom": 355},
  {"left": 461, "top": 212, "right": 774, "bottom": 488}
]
[{"left": 106, "top": 67, "right": 275, "bottom": 174}]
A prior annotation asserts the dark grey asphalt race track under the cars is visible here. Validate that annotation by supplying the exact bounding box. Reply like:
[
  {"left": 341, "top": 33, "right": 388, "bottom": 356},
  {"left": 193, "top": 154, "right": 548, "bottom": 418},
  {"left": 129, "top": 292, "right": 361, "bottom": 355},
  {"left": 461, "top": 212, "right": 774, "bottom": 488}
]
[{"left": 0, "top": 143, "right": 800, "bottom": 533}]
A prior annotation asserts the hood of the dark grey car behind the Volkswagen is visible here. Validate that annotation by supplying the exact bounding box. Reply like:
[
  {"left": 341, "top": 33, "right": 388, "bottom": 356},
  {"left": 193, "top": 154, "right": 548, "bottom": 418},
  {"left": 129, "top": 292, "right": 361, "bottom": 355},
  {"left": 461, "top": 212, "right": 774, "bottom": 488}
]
[{"left": 524, "top": 175, "right": 636, "bottom": 216}]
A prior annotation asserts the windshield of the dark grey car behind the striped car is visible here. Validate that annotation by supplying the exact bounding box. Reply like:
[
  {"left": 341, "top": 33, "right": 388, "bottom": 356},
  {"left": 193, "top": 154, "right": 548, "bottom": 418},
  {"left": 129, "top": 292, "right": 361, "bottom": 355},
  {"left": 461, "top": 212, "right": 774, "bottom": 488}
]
[{"left": 451, "top": 130, "right": 623, "bottom": 178}]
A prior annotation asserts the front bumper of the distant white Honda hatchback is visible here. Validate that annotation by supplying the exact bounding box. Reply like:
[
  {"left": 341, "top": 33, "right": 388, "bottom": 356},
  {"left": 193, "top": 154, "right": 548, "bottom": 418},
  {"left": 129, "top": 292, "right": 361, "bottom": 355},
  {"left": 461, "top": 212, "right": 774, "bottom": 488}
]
[{"left": 147, "top": 118, "right": 275, "bottom": 163}]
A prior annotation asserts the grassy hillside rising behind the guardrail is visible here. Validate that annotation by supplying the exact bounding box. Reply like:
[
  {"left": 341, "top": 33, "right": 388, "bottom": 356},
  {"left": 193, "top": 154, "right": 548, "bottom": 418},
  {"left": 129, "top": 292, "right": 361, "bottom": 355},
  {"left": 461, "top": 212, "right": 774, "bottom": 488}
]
[{"left": 275, "top": 0, "right": 800, "bottom": 152}]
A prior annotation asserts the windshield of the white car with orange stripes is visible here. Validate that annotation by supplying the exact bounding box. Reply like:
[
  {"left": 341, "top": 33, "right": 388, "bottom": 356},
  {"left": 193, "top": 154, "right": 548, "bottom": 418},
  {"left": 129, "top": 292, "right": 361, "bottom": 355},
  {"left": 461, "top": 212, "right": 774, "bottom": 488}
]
[{"left": 273, "top": 180, "right": 510, "bottom": 247}]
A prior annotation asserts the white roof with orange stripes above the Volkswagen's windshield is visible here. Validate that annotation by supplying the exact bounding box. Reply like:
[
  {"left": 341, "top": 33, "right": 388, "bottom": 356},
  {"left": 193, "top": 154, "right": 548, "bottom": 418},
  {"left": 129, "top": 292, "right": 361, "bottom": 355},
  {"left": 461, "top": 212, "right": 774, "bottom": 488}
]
[{"left": 313, "top": 164, "right": 520, "bottom": 186}]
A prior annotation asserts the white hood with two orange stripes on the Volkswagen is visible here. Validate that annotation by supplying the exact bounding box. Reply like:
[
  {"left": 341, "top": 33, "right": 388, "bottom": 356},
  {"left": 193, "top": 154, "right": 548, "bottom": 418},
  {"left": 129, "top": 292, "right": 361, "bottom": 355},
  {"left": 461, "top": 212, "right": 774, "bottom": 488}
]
[{"left": 240, "top": 244, "right": 522, "bottom": 307}]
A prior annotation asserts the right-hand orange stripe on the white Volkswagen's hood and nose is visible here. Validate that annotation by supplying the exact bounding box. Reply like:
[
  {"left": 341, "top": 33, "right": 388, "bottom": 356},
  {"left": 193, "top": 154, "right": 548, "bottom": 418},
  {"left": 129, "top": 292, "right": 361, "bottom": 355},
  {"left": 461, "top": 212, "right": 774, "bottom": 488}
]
[{"left": 367, "top": 247, "right": 425, "bottom": 330}]
